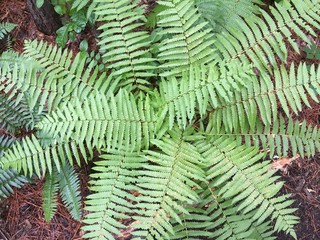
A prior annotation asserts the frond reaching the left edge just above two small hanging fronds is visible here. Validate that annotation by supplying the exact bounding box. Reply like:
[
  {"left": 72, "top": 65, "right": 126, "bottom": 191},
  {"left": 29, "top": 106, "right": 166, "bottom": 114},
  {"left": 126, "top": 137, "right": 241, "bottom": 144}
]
[{"left": 0, "top": 135, "right": 92, "bottom": 177}]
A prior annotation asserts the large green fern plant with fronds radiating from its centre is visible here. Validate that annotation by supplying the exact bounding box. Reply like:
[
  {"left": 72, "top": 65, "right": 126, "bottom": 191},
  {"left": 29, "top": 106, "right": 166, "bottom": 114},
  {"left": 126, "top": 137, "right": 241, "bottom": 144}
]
[{"left": 0, "top": 0, "right": 320, "bottom": 240}]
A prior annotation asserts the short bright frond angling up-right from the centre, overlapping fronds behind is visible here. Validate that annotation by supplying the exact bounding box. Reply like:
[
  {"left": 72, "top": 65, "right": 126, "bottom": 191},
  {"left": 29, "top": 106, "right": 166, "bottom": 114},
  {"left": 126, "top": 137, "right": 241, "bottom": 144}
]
[{"left": 159, "top": 62, "right": 254, "bottom": 129}]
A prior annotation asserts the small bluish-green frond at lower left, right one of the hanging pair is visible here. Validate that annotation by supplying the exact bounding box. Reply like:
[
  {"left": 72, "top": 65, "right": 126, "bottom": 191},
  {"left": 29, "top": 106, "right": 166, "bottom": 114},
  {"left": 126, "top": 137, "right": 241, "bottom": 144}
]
[{"left": 54, "top": 163, "right": 81, "bottom": 221}]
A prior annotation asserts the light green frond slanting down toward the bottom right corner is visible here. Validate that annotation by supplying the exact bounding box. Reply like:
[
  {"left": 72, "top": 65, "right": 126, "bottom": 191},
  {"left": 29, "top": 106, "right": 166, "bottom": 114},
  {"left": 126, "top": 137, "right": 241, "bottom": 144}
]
[{"left": 197, "top": 137, "right": 298, "bottom": 239}]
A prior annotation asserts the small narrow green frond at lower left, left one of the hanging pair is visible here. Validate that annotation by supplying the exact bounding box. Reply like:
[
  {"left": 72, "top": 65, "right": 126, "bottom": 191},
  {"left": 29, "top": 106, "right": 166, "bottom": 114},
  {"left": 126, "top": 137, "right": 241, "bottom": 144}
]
[{"left": 42, "top": 173, "right": 58, "bottom": 222}]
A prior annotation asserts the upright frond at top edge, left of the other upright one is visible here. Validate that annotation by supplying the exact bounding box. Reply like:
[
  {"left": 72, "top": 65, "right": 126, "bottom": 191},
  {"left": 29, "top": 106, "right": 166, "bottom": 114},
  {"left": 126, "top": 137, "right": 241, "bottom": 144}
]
[{"left": 94, "top": 0, "right": 156, "bottom": 86}]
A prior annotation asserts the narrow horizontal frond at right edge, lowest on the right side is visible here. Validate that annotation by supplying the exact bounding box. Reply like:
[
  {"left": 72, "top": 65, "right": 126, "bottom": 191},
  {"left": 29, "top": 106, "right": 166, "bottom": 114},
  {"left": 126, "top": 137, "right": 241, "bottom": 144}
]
[{"left": 207, "top": 116, "right": 320, "bottom": 157}]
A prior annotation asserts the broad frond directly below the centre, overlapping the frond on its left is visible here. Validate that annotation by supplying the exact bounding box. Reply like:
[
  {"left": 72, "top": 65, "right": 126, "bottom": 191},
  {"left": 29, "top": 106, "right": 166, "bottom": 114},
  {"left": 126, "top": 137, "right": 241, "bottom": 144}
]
[{"left": 133, "top": 132, "right": 204, "bottom": 240}]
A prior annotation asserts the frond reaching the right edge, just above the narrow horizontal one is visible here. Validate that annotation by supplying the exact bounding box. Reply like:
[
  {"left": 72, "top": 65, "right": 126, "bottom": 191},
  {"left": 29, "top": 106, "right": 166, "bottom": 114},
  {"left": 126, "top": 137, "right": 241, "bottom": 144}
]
[{"left": 211, "top": 64, "right": 320, "bottom": 132}]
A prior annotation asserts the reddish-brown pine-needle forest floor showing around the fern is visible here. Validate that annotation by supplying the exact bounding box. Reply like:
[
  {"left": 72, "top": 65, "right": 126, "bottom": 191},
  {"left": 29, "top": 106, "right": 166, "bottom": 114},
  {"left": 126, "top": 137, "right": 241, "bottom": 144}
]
[{"left": 0, "top": 0, "right": 320, "bottom": 240}]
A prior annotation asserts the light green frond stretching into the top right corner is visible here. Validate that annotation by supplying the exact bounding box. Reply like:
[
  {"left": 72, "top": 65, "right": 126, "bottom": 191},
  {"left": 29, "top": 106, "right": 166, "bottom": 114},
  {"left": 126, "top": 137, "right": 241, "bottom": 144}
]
[{"left": 215, "top": 0, "right": 320, "bottom": 71}]
